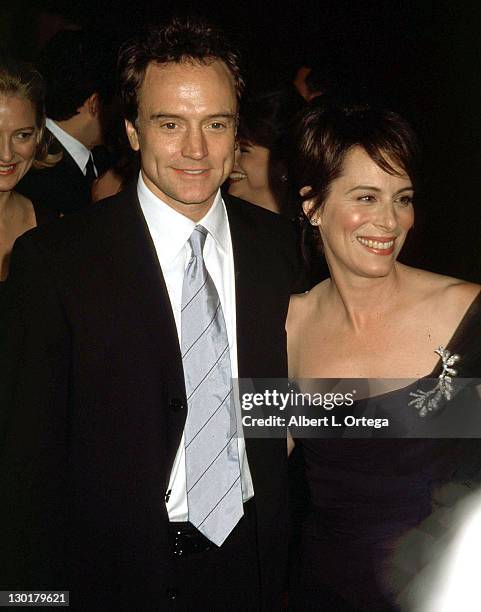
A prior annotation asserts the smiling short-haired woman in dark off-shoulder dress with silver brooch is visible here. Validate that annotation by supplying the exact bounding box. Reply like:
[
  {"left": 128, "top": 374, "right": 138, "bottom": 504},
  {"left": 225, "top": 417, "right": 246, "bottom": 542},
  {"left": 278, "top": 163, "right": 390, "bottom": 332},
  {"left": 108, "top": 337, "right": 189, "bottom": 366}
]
[{"left": 287, "top": 105, "right": 481, "bottom": 612}]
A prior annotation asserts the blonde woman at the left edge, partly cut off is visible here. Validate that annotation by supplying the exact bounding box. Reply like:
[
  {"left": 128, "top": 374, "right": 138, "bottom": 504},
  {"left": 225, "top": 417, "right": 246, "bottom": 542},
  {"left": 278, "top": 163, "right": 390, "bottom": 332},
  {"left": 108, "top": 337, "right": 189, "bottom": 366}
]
[{"left": 0, "top": 61, "right": 58, "bottom": 281}]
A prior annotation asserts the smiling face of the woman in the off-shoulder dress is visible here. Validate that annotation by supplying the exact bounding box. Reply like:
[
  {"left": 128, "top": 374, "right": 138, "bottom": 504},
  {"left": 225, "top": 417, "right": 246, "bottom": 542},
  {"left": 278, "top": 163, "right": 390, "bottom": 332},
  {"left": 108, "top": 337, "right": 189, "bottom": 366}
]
[{"left": 304, "top": 146, "right": 414, "bottom": 277}]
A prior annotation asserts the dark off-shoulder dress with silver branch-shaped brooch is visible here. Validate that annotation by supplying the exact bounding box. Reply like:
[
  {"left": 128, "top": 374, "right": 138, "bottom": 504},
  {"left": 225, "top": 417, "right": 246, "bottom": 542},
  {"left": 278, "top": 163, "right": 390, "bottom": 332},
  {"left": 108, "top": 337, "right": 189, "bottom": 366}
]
[{"left": 289, "top": 294, "right": 481, "bottom": 612}]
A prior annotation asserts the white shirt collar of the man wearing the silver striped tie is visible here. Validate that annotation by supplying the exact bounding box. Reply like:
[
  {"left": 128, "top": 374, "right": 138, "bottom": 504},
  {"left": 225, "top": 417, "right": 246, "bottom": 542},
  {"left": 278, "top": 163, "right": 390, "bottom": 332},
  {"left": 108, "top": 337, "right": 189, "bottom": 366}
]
[{"left": 137, "top": 172, "right": 229, "bottom": 266}]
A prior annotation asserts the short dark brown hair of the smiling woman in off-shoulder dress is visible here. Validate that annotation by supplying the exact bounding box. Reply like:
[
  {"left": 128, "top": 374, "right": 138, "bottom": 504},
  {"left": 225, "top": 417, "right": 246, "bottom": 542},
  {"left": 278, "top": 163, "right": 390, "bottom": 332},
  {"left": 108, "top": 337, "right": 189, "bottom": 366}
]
[{"left": 292, "top": 99, "right": 419, "bottom": 224}]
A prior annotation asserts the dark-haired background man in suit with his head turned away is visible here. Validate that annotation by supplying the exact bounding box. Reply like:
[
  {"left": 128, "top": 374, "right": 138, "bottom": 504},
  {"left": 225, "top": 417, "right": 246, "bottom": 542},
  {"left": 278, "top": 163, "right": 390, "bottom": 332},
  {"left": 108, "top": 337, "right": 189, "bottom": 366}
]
[{"left": 17, "top": 30, "right": 111, "bottom": 214}]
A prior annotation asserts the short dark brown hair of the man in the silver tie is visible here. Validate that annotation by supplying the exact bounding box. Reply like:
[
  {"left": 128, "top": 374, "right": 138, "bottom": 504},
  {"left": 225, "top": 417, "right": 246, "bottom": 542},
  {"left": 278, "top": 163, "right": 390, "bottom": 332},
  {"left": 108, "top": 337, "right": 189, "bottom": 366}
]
[{"left": 119, "top": 17, "right": 244, "bottom": 123}]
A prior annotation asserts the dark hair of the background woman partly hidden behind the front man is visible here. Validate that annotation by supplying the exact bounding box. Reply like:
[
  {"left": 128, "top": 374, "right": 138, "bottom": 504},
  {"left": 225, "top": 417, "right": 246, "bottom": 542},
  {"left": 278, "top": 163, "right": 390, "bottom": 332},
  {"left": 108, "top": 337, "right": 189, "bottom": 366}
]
[{"left": 237, "top": 86, "right": 306, "bottom": 216}]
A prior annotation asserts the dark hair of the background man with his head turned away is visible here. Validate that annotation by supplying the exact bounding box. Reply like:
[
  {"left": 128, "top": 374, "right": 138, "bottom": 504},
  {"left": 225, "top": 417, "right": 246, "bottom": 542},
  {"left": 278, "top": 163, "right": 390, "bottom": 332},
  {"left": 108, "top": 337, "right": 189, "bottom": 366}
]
[{"left": 39, "top": 30, "right": 113, "bottom": 121}]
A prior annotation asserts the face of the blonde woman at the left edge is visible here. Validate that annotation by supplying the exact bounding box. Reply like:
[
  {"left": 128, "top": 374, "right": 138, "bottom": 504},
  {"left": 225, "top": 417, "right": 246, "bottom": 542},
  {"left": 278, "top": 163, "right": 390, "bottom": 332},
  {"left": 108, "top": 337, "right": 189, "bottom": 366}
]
[{"left": 0, "top": 94, "right": 39, "bottom": 191}]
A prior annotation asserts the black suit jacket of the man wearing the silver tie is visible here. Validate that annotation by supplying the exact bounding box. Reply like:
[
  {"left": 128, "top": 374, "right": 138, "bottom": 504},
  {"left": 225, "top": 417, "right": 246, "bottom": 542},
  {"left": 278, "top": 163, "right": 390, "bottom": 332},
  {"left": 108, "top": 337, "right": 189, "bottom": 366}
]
[{"left": 0, "top": 188, "right": 296, "bottom": 610}]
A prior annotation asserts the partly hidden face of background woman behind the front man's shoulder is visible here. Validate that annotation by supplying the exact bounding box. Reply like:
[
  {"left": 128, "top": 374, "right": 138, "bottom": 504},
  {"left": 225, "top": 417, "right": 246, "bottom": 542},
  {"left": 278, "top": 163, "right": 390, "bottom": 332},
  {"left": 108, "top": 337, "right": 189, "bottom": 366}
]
[{"left": 229, "top": 141, "right": 270, "bottom": 206}]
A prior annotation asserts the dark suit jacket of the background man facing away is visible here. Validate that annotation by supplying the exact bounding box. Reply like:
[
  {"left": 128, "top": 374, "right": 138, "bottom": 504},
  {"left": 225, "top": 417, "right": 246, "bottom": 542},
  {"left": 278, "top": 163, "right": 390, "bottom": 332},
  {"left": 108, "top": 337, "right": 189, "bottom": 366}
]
[{"left": 15, "top": 130, "right": 92, "bottom": 214}]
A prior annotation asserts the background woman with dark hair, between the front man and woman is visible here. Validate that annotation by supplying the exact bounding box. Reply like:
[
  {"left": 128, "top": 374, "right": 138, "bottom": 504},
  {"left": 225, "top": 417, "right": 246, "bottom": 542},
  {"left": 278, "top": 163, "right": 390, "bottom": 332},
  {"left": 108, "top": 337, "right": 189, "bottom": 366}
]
[{"left": 229, "top": 87, "right": 304, "bottom": 216}]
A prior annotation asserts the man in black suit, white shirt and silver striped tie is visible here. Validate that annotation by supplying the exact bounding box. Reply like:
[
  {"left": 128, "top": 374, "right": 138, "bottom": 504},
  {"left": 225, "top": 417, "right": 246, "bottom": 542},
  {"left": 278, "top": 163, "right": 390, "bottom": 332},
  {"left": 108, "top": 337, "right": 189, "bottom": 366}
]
[{"left": 0, "top": 20, "right": 295, "bottom": 611}]
